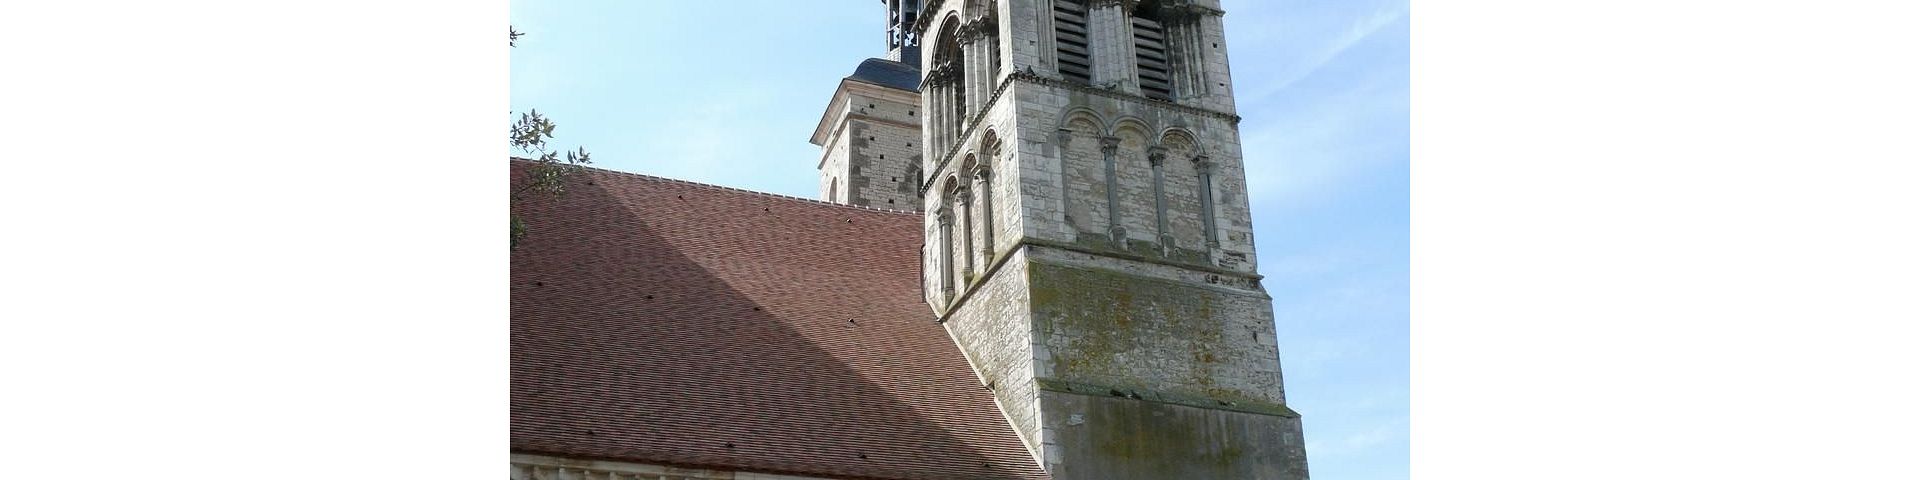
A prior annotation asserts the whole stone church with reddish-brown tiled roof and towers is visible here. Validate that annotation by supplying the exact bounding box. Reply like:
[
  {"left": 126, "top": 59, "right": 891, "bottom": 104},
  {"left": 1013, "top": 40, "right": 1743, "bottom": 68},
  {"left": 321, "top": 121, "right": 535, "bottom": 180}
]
[{"left": 509, "top": 0, "right": 1308, "bottom": 480}]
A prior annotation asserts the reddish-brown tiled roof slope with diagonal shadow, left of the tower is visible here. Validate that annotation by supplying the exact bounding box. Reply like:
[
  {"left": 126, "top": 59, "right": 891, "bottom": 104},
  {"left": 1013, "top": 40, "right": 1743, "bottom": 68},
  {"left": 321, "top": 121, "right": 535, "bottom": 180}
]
[{"left": 513, "top": 161, "right": 1046, "bottom": 480}]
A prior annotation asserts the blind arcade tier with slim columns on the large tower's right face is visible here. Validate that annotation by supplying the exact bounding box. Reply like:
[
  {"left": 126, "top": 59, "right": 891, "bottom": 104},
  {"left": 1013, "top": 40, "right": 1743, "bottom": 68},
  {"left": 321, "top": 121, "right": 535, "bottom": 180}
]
[{"left": 1010, "top": 81, "right": 1258, "bottom": 275}]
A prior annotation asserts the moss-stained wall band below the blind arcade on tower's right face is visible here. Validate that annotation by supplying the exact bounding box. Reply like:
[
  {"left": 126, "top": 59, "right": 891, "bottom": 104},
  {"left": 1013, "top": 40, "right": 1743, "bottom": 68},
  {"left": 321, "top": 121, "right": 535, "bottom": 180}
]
[{"left": 1027, "top": 248, "right": 1286, "bottom": 405}]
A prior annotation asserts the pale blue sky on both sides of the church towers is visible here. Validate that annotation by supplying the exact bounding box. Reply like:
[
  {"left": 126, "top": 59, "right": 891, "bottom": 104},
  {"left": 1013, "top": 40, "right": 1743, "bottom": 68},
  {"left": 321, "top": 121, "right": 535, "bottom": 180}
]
[{"left": 503, "top": 0, "right": 1407, "bottom": 478}]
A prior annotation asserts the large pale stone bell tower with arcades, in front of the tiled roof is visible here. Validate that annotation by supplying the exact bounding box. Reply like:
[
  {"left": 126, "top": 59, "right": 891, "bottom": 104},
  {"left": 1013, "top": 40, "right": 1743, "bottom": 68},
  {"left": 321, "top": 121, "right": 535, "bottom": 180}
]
[{"left": 906, "top": 0, "right": 1308, "bottom": 480}]
